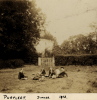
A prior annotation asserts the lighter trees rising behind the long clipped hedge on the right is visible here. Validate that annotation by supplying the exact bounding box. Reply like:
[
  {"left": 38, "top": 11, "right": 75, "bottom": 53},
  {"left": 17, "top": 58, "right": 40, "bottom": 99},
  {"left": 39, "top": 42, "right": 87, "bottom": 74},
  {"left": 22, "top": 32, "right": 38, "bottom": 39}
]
[{"left": 61, "top": 32, "right": 96, "bottom": 54}]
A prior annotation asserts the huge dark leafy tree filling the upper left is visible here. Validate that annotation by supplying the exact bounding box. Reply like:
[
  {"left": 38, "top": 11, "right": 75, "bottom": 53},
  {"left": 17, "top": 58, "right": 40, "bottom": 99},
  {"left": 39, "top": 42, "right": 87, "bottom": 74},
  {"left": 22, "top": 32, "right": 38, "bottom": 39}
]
[{"left": 0, "top": 0, "right": 45, "bottom": 57}]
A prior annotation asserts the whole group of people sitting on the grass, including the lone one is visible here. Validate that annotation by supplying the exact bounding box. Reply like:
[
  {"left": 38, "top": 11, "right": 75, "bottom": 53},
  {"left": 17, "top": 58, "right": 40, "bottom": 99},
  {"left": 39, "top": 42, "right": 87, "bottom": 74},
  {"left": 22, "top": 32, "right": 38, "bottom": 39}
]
[{"left": 18, "top": 67, "right": 68, "bottom": 80}]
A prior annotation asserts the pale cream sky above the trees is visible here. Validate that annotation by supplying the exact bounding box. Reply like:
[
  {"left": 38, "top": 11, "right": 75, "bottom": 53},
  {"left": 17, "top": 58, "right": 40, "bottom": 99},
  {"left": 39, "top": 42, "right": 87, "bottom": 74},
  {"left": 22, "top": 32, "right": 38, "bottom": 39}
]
[{"left": 36, "top": 0, "right": 97, "bottom": 45}]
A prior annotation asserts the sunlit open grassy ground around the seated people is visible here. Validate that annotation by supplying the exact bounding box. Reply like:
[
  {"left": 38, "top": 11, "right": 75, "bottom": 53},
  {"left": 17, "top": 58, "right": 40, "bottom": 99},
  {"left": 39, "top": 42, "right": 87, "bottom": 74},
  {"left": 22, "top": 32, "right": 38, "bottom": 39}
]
[{"left": 0, "top": 65, "right": 97, "bottom": 93}]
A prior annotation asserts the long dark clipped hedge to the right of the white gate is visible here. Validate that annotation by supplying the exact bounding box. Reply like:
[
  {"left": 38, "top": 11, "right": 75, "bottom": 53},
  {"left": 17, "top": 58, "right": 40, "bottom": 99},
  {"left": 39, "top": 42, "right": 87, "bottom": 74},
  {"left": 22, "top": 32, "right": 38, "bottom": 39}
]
[{"left": 55, "top": 54, "right": 97, "bottom": 66}]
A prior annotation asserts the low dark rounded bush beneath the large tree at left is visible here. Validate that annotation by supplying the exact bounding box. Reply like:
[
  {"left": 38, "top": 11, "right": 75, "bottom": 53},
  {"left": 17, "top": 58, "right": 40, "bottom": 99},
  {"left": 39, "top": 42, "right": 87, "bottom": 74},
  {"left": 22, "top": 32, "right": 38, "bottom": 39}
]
[{"left": 3, "top": 59, "right": 24, "bottom": 68}]
